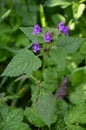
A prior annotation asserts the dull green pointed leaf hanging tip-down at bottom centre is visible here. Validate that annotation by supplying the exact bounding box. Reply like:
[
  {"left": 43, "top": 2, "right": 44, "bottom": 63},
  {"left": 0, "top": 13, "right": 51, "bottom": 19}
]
[{"left": 33, "top": 93, "right": 57, "bottom": 127}]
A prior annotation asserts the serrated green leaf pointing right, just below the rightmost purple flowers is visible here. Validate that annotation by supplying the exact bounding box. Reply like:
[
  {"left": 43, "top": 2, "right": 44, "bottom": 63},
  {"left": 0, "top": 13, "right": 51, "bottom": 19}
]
[{"left": 56, "top": 36, "right": 85, "bottom": 53}]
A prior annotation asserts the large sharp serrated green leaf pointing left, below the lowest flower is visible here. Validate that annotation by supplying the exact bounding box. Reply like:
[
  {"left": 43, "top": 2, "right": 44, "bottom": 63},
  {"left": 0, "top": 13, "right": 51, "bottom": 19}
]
[{"left": 2, "top": 49, "right": 41, "bottom": 77}]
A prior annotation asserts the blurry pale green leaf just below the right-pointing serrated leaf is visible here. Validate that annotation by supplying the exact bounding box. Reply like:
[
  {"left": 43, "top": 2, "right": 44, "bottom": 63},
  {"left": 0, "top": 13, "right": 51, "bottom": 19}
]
[{"left": 49, "top": 47, "right": 66, "bottom": 70}]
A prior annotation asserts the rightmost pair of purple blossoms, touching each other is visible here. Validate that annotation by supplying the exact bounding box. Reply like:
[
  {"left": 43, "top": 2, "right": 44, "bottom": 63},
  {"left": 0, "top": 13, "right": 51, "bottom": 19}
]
[{"left": 57, "top": 22, "right": 69, "bottom": 36}]
